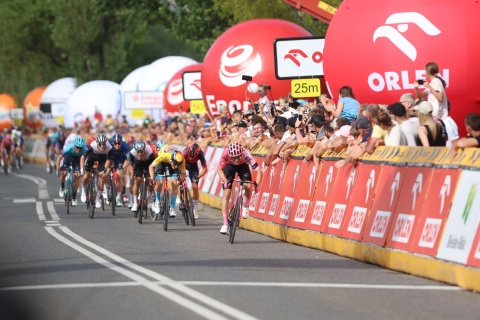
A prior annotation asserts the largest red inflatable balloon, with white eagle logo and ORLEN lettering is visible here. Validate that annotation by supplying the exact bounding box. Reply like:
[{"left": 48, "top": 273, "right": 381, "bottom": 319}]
[{"left": 324, "top": 0, "right": 480, "bottom": 133}]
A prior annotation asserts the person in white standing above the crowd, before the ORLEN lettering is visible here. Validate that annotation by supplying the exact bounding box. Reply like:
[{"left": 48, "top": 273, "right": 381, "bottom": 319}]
[{"left": 414, "top": 62, "right": 448, "bottom": 121}]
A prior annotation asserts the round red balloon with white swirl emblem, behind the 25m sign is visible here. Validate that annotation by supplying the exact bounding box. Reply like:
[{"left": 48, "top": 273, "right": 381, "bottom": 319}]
[{"left": 202, "top": 19, "right": 311, "bottom": 115}]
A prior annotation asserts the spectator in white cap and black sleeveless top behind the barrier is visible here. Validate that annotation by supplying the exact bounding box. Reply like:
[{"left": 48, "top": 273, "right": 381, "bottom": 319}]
[{"left": 415, "top": 101, "right": 447, "bottom": 147}]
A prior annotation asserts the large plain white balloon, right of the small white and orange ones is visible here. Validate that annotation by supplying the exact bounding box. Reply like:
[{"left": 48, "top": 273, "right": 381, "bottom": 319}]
[{"left": 64, "top": 80, "right": 120, "bottom": 128}]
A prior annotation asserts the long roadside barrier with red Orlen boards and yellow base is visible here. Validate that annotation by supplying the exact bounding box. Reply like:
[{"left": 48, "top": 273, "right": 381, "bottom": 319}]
[{"left": 27, "top": 139, "right": 480, "bottom": 291}]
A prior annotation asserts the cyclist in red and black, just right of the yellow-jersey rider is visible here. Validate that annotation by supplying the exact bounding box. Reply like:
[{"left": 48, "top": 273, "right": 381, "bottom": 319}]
[{"left": 182, "top": 143, "right": 208, "bottom": 219}]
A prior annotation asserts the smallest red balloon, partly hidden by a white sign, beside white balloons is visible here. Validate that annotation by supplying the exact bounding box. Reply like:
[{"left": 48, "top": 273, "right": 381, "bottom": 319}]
[{"left": 163, "top": 63, "right": 203, "bottom": 112}]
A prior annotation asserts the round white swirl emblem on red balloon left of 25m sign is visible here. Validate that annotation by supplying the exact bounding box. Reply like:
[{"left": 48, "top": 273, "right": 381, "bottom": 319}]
[{"left": 218, "top": 44, "right": 262, "bottom": 87}]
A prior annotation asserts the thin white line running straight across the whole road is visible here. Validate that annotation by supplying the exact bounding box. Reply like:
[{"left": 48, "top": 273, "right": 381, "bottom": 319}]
[{"left": 0, "top": 281, "right": 464, "bottom": 291}]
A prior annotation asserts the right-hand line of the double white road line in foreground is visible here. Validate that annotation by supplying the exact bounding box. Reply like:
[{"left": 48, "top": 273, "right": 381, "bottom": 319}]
[{"left": 60, "top": 226, "right": 257, "bottom": 320}]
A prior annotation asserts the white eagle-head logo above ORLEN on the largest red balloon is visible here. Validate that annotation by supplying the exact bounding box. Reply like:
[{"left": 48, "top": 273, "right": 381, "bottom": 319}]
[{"left": 373, "top": 12, "right": 441, "bottom": 61}]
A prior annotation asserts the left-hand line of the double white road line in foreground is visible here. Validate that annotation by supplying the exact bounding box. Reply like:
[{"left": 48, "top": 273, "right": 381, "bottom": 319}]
[{"left": 45, "top": 227, "right": 248, "bottom": 320}]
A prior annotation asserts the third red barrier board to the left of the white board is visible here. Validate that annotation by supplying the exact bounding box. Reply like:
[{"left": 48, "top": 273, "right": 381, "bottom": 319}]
[{"left": 362, "top": 165, "right": 405, "bottom": 247}]
